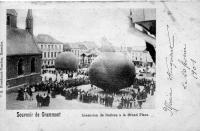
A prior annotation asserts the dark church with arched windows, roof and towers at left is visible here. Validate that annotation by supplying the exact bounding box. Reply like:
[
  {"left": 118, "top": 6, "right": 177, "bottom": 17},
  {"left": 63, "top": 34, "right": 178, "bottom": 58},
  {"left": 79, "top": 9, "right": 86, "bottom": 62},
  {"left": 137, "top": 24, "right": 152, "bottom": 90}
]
[{"left": 6, "top": 9, "right": 42, "bottom": 90}]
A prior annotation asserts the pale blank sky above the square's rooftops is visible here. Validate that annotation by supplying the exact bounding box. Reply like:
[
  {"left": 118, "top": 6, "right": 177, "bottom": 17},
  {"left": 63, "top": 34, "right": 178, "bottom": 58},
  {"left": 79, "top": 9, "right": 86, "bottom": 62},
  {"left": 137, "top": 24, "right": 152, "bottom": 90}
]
[{"left": 16, "top": 8, "right": 145, "bottom": 46}]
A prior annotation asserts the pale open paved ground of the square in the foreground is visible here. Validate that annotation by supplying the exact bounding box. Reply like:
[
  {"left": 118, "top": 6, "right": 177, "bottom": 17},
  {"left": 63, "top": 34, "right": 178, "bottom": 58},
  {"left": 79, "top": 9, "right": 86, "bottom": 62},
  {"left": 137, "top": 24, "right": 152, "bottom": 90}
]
[{"left": 6, "top": 85, "right": 155, "bottom": 109}]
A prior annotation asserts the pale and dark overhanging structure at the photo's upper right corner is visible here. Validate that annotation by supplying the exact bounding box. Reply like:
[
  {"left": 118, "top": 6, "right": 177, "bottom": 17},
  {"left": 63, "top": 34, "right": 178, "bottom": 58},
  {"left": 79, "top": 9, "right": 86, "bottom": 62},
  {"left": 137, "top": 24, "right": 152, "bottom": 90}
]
[{"left": 129, "top": 8, "right": 156, "bottom": 63}]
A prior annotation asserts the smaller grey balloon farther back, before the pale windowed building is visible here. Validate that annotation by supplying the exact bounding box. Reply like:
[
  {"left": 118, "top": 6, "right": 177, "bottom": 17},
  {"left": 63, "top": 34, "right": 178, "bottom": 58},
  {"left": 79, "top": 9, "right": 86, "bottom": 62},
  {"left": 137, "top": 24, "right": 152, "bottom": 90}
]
[{"left": 55, "top": 52, "right": 78, "bottom": 71}]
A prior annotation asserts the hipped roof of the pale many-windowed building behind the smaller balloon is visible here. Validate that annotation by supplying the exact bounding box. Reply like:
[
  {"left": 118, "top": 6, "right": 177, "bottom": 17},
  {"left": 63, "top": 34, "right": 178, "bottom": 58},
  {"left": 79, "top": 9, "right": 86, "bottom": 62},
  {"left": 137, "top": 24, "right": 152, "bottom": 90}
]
[{"left": 35, "top": 34, "right": 63, "bottom": 44}]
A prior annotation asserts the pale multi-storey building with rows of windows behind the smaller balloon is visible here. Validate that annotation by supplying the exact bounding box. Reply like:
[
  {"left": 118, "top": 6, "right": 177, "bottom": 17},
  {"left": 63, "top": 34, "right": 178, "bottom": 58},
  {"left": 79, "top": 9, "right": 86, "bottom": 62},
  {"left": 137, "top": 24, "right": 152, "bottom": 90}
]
[{"left": 35, "top": 34, "right": 63, "bottom": 70}]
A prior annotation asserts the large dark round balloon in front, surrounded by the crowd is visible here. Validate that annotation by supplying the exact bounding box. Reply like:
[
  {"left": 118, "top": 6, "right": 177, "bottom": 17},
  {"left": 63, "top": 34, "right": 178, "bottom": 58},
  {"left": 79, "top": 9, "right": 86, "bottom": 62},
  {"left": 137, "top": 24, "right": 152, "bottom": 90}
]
[{"left": 89, "top": 52, "right": 135, "bottom": 92}]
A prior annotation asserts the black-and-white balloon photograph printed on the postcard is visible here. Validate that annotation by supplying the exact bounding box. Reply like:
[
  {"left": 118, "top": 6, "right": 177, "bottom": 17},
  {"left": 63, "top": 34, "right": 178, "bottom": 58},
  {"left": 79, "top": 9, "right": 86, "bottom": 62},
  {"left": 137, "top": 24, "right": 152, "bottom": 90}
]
[{"left": 6, "top": 8, "right": 157, "bottom": 110}]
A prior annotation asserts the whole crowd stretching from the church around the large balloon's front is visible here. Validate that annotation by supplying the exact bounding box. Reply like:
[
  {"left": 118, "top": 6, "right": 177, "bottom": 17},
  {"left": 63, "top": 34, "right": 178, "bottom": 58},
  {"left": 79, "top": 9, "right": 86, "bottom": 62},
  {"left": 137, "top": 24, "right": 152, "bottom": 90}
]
[{"left": 17, "top": 69, "right": 155, "bottom": 109}]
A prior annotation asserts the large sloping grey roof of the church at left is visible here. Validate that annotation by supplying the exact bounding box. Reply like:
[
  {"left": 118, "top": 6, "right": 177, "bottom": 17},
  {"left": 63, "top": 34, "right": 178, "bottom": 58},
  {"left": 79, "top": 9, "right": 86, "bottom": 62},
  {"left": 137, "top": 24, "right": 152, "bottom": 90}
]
[{"left": 7, "top": 27, "right": 41, "bottom": 56}]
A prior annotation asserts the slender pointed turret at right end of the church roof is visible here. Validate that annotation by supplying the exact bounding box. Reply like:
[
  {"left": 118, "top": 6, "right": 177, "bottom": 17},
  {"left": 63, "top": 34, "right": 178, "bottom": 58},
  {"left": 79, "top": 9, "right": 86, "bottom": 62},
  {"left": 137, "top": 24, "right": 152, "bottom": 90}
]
[{"left": 26, "top": 9, "right": 33, "bottom": 35}]
